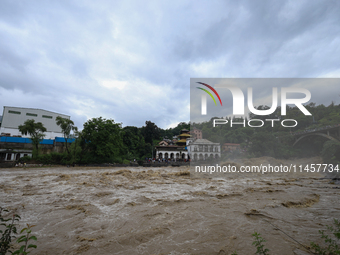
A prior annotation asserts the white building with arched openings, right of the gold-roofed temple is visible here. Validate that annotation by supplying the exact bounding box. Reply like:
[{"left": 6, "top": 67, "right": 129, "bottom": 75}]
[{"left": 187, "top": 139, "right": 221, "bottom": 161}]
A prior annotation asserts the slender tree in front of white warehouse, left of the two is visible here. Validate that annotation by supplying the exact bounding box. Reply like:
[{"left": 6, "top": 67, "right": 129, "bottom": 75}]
[{"left": 19, "top": 119, "right": 46, "bottom": 156}]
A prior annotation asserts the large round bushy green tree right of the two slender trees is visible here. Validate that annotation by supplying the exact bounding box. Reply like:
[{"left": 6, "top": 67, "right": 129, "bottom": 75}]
[{"left": 80, "top": 117, "right": 125, "bottom": 163}]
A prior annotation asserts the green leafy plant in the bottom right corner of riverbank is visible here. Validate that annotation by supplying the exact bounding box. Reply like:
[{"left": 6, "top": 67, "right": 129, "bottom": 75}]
[{"left": 311, "top": 219, "right": 340, "bottom": 255}]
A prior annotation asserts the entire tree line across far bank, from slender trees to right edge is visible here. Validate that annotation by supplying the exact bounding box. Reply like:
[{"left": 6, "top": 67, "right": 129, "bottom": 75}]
[{"left": 19, "top": 100, "right": 340, "bottom": 164}]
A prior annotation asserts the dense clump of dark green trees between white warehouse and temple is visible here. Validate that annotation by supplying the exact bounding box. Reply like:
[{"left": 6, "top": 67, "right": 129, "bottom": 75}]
[{"left": 61, "top": 117, "right": 165, "bottom": 164}]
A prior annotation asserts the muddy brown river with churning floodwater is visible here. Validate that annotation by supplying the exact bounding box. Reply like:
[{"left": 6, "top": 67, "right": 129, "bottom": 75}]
[{"left": 0, "top": 157, "right": 340, "bottom": 255}]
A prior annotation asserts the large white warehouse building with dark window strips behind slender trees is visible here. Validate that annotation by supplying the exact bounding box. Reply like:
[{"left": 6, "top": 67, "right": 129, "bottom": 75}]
[{"left": 0, "top": 106, "right": 70, "bottom": 139}]
